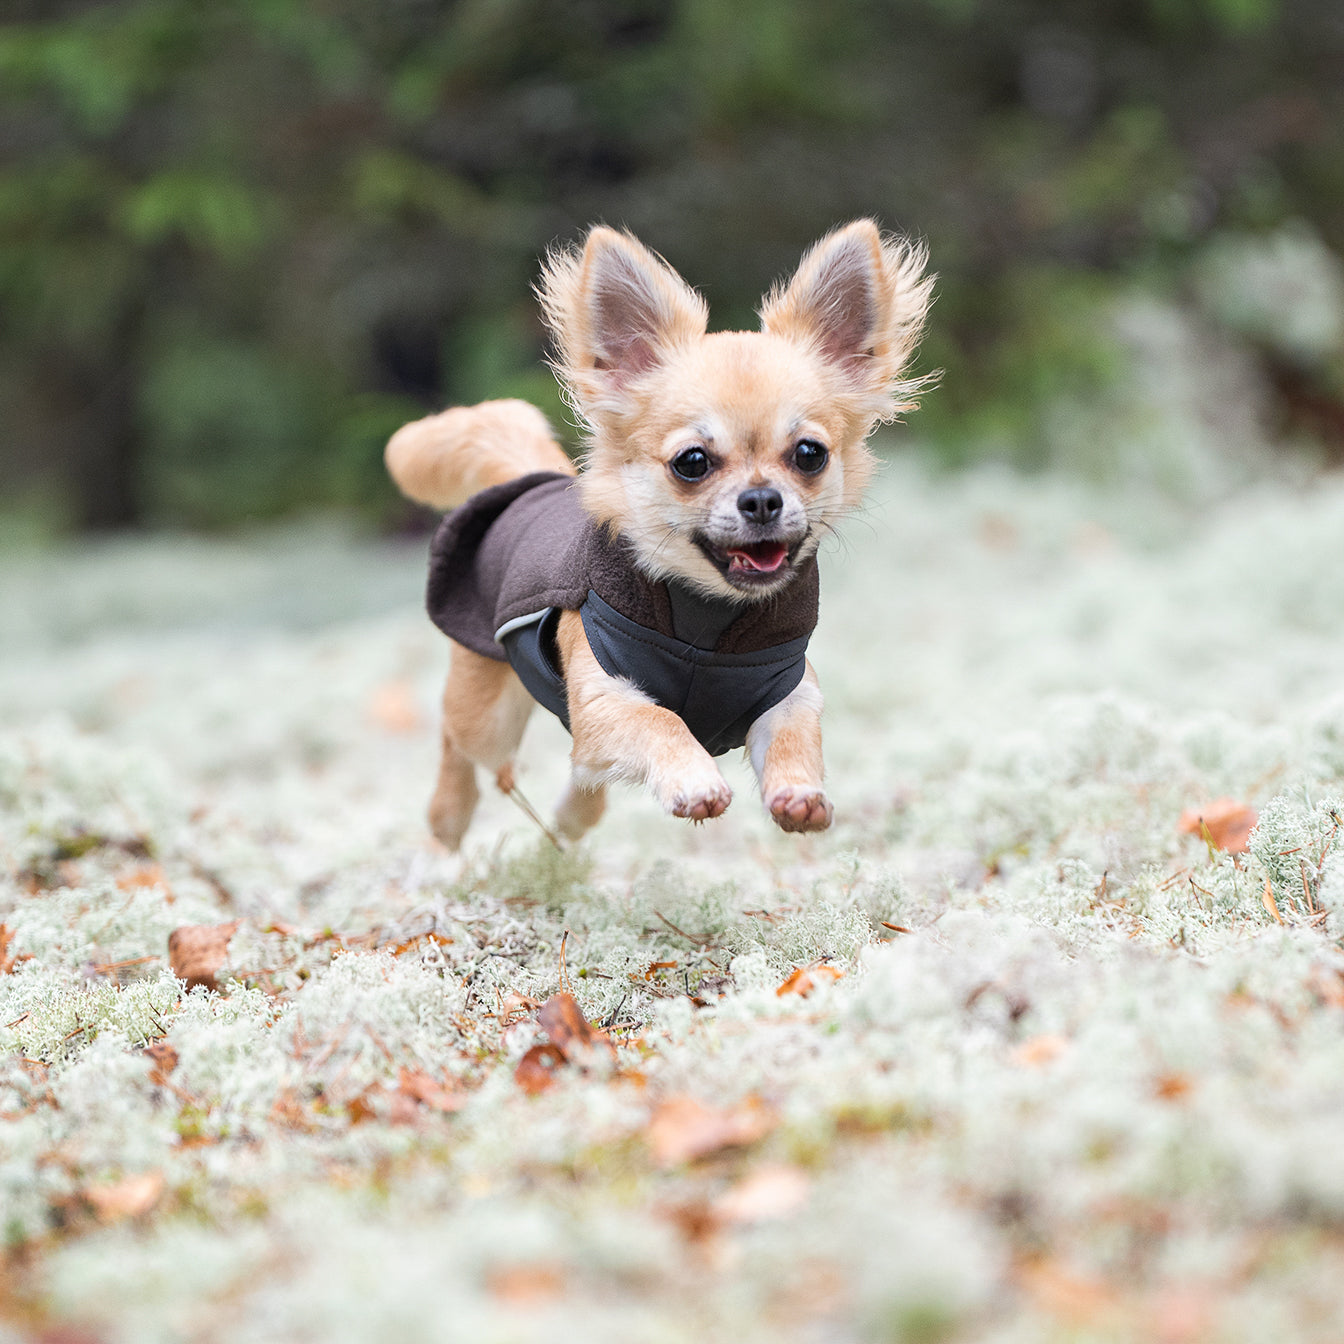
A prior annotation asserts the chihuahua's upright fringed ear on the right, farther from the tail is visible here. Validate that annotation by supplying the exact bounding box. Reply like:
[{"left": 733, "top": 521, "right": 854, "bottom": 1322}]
[{"left": 761, "top": 219, "right": 933, "bottom": 419}]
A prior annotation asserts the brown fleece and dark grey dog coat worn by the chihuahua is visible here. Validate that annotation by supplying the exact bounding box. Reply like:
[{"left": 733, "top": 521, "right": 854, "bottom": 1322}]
[{"left": 426, "top": 472, "right": 818, "bottom": 755}]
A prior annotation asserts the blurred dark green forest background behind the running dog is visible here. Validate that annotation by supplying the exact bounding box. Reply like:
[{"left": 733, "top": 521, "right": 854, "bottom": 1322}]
[{"left": 0, "top": 0, "right": 1344, "bottom": 531}]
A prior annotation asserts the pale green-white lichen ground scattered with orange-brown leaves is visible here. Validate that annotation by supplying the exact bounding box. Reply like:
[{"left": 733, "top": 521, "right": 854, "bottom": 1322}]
[{"left": 0, "top": 451, "right": 1344, "bottom": 1344}]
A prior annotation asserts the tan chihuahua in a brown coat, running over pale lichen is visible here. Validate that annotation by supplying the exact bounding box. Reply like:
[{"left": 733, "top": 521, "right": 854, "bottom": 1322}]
[{"left": 387, "top": 219, "right": 933, "bottom": 849}]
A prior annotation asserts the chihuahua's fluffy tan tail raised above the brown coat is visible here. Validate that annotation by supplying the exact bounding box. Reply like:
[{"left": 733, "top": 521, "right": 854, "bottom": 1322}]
[{"left": 383, "top": 401, "right": 574, "bottom": 511}]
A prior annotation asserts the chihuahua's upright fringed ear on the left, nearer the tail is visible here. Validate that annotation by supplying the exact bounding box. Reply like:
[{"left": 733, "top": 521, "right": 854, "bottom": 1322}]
[{"left": 538, "top": 226, "right": 710, "bottom": 417}]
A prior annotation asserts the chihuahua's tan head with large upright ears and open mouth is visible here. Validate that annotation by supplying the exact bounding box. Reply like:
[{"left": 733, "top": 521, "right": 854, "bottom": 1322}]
[{"left": 539, "top": 219, "right": 933, "bottom": 599}]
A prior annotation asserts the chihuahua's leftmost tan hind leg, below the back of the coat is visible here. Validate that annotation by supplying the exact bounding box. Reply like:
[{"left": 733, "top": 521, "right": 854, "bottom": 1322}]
[{"left": 429, "top": 644, "right": 532, "bottom": 849}]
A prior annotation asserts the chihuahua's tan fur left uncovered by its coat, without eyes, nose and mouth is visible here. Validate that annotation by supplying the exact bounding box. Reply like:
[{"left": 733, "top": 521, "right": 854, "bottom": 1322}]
[{"left": 387, "top": 220, "right": 933, "bottom": 848}]
